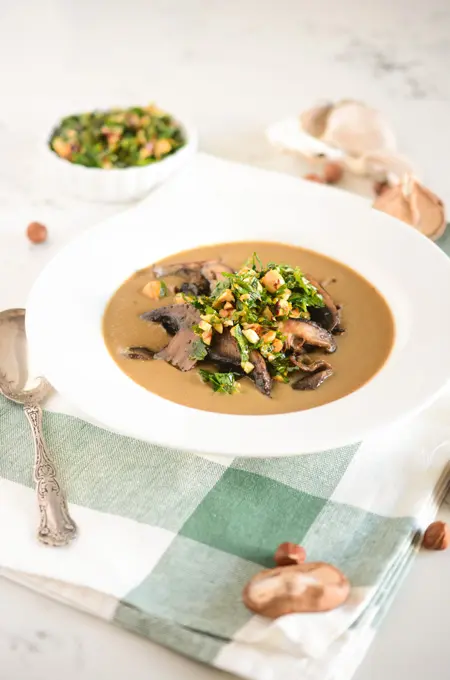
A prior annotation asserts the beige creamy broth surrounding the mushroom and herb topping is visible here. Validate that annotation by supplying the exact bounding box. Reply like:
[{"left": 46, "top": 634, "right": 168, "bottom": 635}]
[{"left": 103, "top": 242, "right": 394, "bottom": 415}]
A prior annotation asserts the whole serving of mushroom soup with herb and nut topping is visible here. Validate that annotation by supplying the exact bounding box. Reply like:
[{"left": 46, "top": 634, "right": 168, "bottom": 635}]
[{"left": 103, "top": 242, "right": 394, "bottom": 415}]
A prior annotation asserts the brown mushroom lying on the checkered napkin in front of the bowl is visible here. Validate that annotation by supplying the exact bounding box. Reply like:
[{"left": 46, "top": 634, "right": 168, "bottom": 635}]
[{"left": 242, "top": 562, "right": 350, "bottom": 619}]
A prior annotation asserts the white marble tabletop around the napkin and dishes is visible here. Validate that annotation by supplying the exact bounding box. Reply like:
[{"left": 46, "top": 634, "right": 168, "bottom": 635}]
[{"left": 0, "top": 0, "right": 450, "bottom": 680}]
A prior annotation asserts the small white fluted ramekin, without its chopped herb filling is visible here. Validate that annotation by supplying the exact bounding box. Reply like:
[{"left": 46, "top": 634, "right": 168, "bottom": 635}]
[{"left": 41, "top": 122, "right": 198, "bottom": 203}]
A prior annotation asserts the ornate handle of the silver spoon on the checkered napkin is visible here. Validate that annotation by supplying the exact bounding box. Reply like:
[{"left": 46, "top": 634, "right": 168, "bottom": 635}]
[{"left": 24, "top": 404, "right": 77, "bottom": 546}]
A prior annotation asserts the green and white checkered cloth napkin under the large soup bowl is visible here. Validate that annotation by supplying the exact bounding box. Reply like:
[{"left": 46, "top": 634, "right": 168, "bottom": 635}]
[{"left": 0, "top": 161, "right": 450, "bottom": 680}]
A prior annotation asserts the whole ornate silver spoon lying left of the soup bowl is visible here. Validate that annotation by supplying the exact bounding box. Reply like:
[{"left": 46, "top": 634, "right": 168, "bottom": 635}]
[{"left": 0, "top": 309, "right": 77, "bottom": 546}]
